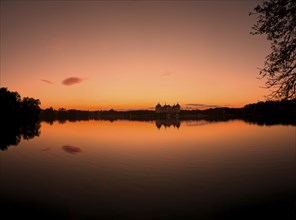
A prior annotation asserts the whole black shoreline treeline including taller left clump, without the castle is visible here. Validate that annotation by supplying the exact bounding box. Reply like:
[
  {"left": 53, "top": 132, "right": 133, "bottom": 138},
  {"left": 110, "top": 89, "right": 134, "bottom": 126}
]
[{"left": 0, "top": 88, "right": 296, "bottom": 123}]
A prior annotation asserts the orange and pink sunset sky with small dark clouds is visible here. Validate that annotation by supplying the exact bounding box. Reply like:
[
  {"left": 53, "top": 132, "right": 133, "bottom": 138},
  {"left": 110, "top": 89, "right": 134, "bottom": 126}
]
[{"left": 0, "top": 0, "right": 270, "bottom": 110}]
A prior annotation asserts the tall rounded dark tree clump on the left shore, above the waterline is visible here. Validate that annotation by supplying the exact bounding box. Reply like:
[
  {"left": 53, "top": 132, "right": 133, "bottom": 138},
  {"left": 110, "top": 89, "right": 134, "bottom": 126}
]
[{"left": 0, "top": 87, "right": 41, "bottom": 122}]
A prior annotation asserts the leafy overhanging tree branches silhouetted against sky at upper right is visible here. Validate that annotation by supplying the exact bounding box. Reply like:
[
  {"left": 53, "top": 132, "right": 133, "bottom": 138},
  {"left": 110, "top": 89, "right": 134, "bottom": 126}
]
[{"left": 250, "top": 0, "right": 296, "bottom": 99}]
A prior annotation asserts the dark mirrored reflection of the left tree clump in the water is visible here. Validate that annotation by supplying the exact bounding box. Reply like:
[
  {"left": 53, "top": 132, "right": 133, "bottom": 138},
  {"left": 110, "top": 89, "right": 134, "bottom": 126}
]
[{"left": 0, "top": 120, "right": 41, "bottom": 150}]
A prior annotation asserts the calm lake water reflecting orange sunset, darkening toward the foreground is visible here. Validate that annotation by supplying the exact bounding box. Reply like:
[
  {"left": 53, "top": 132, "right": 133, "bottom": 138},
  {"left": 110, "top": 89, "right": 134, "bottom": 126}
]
[{"left": 0, "top": 120, "right": 296, "bottom": 219}]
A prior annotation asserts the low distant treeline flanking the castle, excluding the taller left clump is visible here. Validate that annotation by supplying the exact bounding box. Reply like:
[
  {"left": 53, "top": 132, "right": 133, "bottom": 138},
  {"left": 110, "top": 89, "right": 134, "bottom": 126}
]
[{"left": 40, "top": 99, "right": 296, "bottom": 123}]
